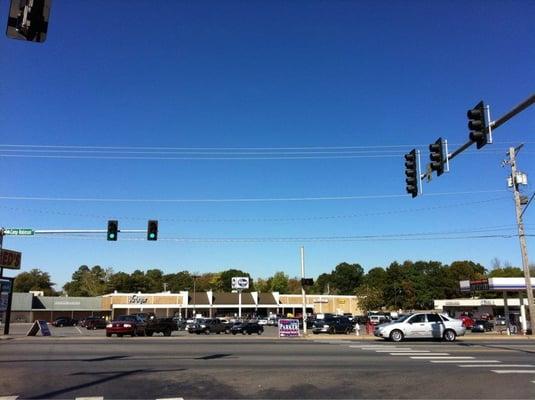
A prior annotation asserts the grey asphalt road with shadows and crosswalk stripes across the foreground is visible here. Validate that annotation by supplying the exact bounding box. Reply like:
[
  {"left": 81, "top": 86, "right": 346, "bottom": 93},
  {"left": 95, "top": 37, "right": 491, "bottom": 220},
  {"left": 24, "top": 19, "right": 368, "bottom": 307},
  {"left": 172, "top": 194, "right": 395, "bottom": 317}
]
[{"left": 0, "top": 335, "right": 535, "bottom": 399}]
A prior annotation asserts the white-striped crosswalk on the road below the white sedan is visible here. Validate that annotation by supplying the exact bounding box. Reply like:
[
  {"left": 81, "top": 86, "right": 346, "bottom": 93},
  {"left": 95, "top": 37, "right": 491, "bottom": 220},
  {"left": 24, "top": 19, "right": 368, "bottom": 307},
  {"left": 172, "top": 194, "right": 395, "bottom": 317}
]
[{"left": 315, "top": 340, "right": 535, "bottom": 383}]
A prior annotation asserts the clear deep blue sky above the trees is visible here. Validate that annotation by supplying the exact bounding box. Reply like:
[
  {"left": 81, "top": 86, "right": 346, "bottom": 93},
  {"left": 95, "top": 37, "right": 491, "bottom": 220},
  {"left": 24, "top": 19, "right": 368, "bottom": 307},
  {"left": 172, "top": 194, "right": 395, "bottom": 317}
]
[{"left": 0, "top": 1, "right": 535, "bottom": 286}]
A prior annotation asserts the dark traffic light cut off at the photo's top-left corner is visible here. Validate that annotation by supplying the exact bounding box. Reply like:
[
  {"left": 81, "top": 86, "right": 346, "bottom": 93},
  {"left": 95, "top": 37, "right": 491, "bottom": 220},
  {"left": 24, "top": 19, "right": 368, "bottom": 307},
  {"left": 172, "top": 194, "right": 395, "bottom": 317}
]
[{"left": 6, "top": 0, "right": 52, "bottom": 43}]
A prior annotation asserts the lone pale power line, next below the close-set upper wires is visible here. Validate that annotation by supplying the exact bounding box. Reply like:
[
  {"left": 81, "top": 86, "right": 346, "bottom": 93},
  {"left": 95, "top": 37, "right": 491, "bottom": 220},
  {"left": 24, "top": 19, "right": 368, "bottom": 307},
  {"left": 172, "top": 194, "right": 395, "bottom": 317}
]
[{"left": 0, "top": 189, "right": 507, "bottom": 203}]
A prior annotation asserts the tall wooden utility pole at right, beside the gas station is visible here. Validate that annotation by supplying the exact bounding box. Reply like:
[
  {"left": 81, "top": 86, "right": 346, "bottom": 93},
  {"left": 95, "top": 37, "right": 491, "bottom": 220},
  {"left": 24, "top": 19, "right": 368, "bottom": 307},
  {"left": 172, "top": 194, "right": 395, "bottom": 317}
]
[{"left": 509, "top": 147, "right": 535, "bottom": 335}]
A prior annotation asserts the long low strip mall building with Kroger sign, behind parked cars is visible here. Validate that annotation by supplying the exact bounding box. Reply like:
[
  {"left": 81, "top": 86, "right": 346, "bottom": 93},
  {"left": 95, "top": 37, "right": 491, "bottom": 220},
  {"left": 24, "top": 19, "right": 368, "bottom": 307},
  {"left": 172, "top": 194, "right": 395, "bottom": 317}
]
[{"left": 11, "top": 291, "right": 362, "bottom": 322}]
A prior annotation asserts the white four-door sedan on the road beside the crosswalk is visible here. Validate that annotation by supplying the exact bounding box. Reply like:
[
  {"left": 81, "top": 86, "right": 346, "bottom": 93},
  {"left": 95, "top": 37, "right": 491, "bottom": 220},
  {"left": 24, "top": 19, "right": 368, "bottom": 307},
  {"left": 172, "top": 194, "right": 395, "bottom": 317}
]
[{"left": 373, "top": 313, "right": 466, "bottom": 342}]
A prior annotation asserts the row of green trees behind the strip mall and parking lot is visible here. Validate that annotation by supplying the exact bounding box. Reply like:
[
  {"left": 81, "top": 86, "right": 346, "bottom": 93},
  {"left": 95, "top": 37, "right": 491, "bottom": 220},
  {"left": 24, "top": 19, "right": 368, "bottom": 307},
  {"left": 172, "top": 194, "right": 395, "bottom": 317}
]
[{"left": 14, "top": 259, "right": 524, "bottom": 310}]
